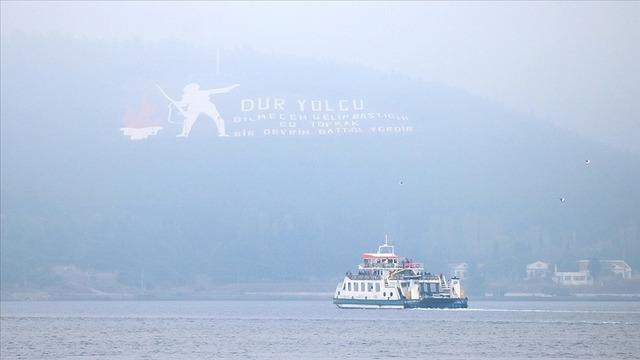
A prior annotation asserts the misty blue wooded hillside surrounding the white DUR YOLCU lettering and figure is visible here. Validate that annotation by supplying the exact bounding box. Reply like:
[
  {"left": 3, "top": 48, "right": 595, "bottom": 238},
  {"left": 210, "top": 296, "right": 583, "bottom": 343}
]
[{"left": 0, "top": 36, "right": 640, "bottom": 296}]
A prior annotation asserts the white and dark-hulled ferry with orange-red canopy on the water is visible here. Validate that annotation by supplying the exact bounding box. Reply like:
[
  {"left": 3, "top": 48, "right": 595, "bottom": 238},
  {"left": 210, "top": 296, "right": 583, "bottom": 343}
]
[{"left": 333, "top": 236, "right": 468, "bottom": 309}]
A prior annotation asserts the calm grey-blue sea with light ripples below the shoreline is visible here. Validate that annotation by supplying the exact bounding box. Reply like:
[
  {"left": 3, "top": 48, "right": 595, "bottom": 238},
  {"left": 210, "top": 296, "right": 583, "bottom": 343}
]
[{"left": 0, "top": 301, "right": 640, "bottom": 359}]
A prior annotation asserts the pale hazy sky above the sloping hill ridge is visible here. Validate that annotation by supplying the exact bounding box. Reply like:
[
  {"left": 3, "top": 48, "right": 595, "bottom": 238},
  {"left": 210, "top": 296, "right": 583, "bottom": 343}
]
[{"left": 2, "top": 1, "right": 640, "bottom": 153}]
